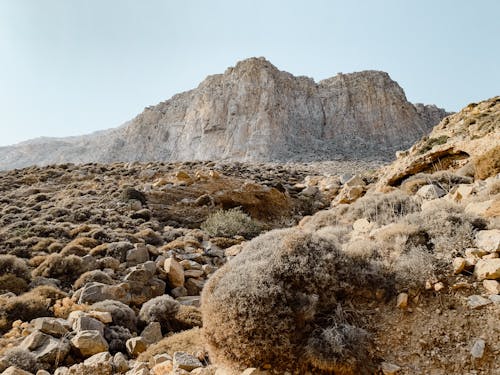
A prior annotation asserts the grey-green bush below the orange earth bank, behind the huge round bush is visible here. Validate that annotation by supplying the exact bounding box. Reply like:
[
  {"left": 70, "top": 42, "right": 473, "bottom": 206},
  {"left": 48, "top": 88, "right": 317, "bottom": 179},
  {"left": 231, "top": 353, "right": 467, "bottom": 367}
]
[{"left": 201, "top": 208, "right": 262, "bottom": 239}]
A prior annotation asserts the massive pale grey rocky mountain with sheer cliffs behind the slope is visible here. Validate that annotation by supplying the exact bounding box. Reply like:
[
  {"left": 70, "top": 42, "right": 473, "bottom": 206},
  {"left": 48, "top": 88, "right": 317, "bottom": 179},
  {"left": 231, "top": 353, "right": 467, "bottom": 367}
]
[{"left": 0, "top": 58, "right": 448, "bottom": 169}]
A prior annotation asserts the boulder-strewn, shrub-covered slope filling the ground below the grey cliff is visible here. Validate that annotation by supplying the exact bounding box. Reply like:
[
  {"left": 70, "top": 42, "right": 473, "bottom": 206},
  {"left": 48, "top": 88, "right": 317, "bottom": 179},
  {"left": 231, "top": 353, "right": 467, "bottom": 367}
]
[{"left": 0, "top": 98, "right": 500, "bottom": 375}]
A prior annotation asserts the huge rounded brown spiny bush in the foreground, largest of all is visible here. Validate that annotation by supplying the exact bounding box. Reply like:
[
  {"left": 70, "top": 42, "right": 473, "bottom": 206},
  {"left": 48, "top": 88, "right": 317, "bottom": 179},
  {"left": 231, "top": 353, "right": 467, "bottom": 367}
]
[{"left": 201, "top": 228, "right": 394, "bottom": 374}]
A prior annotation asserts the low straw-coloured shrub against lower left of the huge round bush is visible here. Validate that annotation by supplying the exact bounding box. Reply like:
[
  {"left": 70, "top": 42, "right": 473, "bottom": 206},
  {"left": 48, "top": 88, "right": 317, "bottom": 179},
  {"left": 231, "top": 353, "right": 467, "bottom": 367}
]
[{"left": 137, "top": 328, "right": 205, "bottom": 362}]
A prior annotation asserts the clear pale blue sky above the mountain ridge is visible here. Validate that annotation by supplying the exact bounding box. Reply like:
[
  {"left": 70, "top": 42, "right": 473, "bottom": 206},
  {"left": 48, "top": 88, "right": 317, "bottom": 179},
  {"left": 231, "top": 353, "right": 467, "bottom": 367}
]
[{"left": 0, "top": 0, "right": 500, "bottom": 145}]
